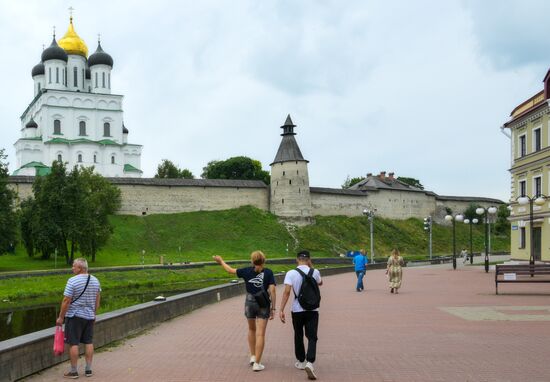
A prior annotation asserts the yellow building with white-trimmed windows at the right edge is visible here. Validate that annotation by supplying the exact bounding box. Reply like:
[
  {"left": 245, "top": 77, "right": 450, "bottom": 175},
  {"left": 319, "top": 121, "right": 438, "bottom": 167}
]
[{"left": 502, "top": 70, "right": 550, "bottom": 261}]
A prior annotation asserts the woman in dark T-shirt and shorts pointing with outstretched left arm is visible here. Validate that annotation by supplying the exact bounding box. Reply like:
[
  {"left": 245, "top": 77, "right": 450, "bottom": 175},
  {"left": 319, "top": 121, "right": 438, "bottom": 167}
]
[{"left": 213, "top": 251, "right": 276, "bottom": 371}]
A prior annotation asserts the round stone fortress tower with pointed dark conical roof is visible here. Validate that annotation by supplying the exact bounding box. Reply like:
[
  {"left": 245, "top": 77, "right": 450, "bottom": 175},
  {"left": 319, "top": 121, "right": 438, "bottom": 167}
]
[{"left": 270, "top": 115, "right": 311, "bottom": 223}]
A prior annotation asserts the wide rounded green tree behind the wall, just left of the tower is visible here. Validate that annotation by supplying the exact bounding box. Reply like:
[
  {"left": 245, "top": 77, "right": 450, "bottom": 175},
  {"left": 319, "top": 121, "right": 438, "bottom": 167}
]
[{"left": 201, "top": 156, "right": 270, "bottom": 184}]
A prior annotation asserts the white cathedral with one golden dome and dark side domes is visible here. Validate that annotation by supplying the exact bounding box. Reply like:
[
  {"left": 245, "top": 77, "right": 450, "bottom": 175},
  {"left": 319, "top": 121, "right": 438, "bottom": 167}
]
[{"left": 13, "top": 16, "right": 142, "bottom": 177}]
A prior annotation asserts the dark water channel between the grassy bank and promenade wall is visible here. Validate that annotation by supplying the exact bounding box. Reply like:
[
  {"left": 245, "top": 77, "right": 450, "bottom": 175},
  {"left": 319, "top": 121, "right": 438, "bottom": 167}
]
[{"left": 0, "top": 289, "right": 193, "bottom": 341}]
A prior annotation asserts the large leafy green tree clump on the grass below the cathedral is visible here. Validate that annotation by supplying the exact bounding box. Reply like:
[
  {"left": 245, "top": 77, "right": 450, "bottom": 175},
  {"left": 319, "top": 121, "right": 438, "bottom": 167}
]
[{"left": 20, "top": 161, "right": 120, "bottom": 264}]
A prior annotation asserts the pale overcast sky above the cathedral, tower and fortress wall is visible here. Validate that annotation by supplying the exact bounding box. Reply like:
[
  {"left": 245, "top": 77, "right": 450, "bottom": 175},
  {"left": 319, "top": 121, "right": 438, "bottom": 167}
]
[{"left": 0, "top": 0, "right": 550, "bottom": 200}]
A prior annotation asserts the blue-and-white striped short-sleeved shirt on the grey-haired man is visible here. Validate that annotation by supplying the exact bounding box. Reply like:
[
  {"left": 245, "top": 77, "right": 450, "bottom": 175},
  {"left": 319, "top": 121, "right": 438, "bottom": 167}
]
[{"left": 63, "top": 274, "right": 101, "bottom": 320}]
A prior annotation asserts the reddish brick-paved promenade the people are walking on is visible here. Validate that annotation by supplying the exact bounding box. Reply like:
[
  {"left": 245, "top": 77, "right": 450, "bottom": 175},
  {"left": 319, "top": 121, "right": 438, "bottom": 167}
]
[{"left": 30, "top": 264, "right": 550, "bottom": 382}]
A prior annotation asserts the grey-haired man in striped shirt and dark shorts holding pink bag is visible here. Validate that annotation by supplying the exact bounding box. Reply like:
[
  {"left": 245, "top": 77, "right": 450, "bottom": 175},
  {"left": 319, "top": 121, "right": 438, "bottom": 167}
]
[{"left": 55, "top": 258, "right": 101, "bottom": 379}]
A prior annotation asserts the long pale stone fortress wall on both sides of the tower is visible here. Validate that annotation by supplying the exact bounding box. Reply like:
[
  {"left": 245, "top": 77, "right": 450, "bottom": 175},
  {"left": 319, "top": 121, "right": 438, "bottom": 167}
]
[{"left": 9, "top": 176, "right": 502, "bottom": 223}]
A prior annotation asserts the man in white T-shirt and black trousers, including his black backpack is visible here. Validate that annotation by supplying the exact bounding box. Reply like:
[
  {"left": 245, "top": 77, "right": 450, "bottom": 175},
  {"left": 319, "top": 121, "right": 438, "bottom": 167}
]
[{"left": 279, "top": 251, "right": 323, "bottom": 380}]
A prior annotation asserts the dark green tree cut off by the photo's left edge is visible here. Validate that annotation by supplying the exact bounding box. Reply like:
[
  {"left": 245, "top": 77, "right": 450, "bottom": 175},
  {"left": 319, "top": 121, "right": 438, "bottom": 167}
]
[{"left": 0, "top": 149, "right": 17, "bottom": 255}]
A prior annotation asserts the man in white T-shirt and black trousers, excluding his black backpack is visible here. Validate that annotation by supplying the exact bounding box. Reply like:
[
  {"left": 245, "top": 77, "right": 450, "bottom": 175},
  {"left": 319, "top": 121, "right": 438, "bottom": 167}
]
[{"left": 279, "top": 251, "right": 323, "bottom": 380}]
